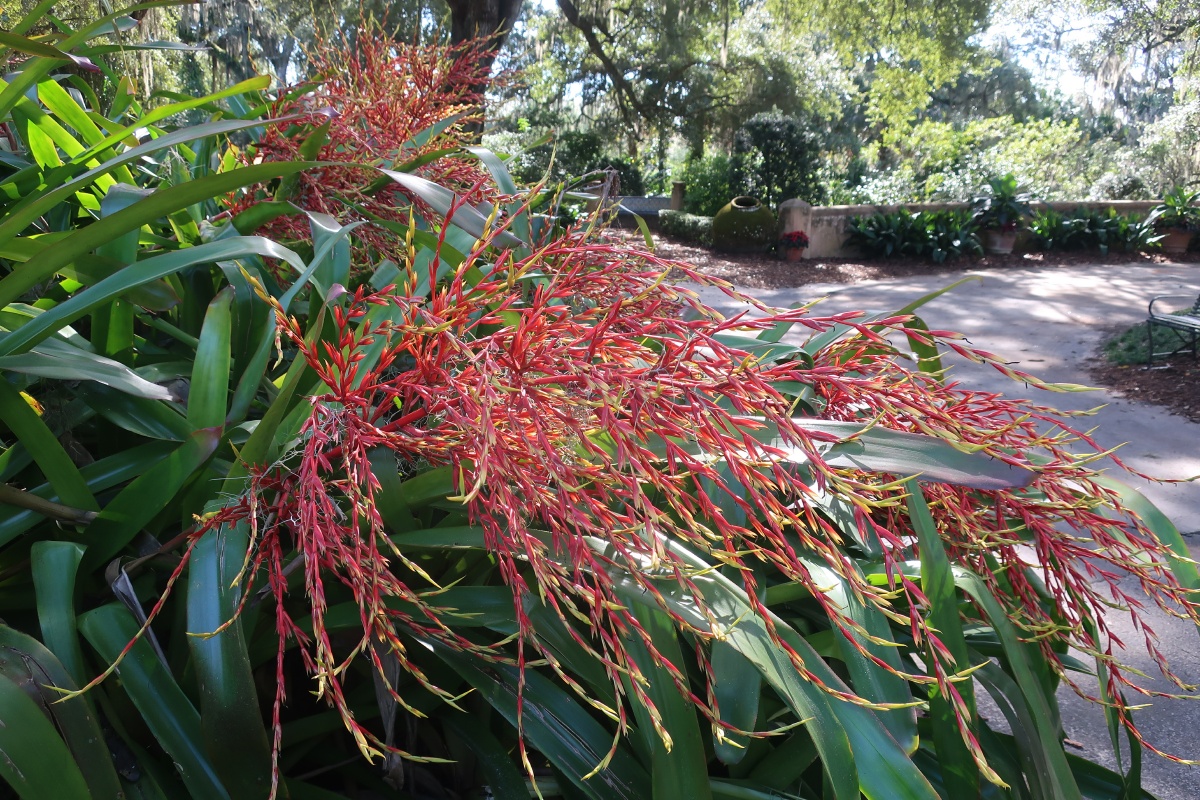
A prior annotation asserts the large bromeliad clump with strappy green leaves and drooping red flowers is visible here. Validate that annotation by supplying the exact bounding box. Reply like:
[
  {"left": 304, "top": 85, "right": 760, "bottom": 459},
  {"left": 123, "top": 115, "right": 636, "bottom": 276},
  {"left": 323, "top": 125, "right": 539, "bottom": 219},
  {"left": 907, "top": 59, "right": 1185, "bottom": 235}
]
[{"left": 0, "top": 9, "right": 1200, "bottom": 800}]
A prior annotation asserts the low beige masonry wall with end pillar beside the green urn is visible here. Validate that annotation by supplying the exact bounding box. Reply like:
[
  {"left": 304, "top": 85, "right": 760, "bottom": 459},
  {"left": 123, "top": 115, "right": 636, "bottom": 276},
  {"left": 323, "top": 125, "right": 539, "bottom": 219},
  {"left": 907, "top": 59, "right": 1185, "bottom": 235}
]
[{"left": 779, "top": 200, "right": 1158, "bottom": 258}]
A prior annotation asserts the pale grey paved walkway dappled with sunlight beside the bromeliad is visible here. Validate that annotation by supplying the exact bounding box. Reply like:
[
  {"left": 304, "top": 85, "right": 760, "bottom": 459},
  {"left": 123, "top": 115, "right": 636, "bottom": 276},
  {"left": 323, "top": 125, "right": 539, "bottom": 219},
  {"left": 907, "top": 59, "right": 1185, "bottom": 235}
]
[{"left": 686, "top": 264, "right": 1200, "bottom": 800}]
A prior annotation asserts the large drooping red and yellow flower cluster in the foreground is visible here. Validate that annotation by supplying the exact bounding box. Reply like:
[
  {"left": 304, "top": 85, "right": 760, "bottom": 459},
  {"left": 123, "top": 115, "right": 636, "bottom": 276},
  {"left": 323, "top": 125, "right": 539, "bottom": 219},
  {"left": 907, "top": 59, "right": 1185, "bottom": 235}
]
[{"left": 182, "top": 206, "right": 1198, "bottom": 796}]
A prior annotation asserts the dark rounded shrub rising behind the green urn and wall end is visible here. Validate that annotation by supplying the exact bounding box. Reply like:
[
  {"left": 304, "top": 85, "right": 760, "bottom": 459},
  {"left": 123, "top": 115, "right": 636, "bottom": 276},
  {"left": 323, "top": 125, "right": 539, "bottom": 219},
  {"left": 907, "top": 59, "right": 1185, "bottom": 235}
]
[{"left": 730, "top": 110, "right": 822, "bottom": 207}]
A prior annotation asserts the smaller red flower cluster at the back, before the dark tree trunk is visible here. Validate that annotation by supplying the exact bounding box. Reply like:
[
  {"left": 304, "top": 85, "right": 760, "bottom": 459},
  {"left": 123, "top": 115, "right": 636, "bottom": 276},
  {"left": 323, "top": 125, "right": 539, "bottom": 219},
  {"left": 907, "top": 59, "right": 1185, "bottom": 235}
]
[{"left": 230, "top": 19, "right": 506, "bottom": 264}]
